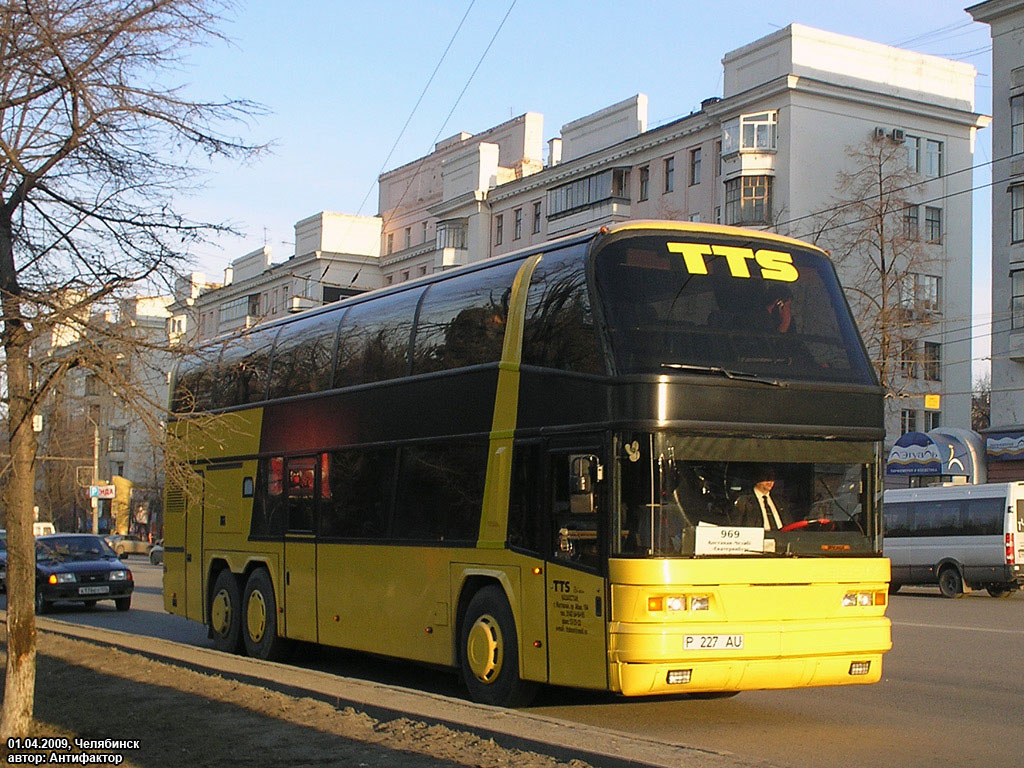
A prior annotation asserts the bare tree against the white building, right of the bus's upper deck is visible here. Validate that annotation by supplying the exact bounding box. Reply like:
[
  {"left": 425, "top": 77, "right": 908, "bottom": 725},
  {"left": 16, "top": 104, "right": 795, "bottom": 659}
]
[{"left": 798, "top": 136, "right": 941, "bottom": 423}]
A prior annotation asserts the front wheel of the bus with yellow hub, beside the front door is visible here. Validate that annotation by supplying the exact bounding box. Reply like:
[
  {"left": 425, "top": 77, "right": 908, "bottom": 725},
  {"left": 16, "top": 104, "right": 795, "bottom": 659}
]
[{"left": 459, "top": 585, "right": 537, "bottom": 707}]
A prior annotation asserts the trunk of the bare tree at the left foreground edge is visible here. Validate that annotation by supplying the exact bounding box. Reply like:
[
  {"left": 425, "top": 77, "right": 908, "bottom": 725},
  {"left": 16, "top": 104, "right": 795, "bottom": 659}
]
[{"left": 0, "top": 219, "right": 36, "bottom": 743}]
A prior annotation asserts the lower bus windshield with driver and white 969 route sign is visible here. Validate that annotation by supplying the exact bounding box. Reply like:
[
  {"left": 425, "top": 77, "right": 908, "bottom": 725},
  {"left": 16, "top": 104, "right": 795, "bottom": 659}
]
[{"left": 612, "top": 434, "right": 876, "bottom": 557}]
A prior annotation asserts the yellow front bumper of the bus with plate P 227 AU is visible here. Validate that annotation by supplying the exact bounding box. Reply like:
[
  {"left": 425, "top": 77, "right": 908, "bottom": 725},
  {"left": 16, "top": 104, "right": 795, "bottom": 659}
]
[{"left": 608, "top": 616, "right": 892, "bottom": 696}]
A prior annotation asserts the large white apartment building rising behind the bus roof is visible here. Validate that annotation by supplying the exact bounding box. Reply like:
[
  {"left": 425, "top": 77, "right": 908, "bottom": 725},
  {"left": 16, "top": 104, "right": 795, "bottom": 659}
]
[{"left": 380, "top": 25, "right": 988, "bottom": 442}]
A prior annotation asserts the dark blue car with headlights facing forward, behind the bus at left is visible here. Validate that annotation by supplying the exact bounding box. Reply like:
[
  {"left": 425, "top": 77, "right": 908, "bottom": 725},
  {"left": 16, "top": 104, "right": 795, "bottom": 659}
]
[{"left": 36, "top": 534, "right": 135, "bottom": 614}]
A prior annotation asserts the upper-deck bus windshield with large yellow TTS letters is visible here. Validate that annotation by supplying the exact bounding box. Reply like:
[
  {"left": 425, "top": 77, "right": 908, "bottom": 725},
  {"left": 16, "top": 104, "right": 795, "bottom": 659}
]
[{"left": 595, "top": 232, "right": 874, "bottom": 384}]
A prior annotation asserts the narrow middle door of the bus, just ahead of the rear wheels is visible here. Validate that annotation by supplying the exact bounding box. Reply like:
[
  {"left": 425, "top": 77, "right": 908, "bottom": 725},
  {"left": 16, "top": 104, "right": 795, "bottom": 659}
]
[{"left": 284, "top": 456, "right": 319, "bottom": 642}]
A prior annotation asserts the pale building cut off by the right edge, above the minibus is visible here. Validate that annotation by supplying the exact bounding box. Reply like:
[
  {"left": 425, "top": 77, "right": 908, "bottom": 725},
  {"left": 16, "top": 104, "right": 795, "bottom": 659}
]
[{"left": 967, "top": 0, "right": 1024, "bottom": 481}]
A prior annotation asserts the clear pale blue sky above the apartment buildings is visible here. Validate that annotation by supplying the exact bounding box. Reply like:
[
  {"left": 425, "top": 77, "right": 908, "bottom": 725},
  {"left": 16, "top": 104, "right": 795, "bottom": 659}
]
[{"left": 172, "top": 0, "right": 991, "bottom": 375}]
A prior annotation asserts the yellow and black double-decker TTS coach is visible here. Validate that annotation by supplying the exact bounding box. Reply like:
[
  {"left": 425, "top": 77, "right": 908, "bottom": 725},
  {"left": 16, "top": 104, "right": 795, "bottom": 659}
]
[{"left": 164, "top": 221, "right": 891, "bottom": 706}]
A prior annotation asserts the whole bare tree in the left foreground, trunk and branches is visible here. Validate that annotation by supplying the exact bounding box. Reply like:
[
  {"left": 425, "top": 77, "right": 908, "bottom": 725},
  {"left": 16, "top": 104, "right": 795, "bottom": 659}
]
[{"left": 0, "top": 0, "right": 259, "bottom": 739}]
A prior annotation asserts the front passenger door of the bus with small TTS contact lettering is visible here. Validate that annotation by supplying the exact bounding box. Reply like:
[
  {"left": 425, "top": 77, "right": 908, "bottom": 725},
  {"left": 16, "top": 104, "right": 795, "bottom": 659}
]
[{"left": 547, "top": 442, "right": 608, "bottom": 688}]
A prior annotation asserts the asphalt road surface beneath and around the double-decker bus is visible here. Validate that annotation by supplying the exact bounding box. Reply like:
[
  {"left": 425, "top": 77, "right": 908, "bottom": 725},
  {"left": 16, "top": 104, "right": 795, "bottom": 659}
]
[{"left": 12, "top": 557, "right": 1024, "bottom": 768}]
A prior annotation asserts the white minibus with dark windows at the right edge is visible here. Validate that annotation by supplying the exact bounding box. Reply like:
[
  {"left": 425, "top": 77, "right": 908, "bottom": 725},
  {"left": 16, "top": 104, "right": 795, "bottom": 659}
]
[{"left": 883, "top": 482, "right": 1024, "bottom": 597}]
